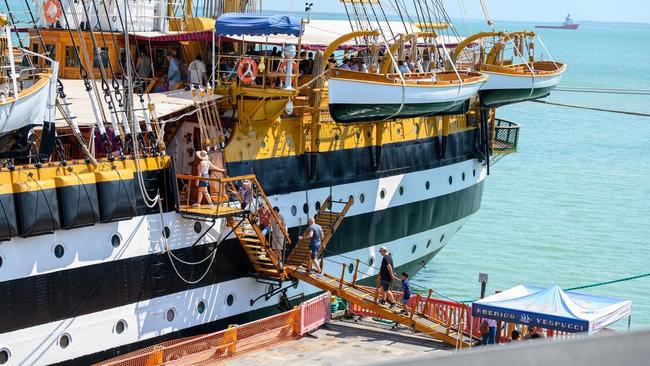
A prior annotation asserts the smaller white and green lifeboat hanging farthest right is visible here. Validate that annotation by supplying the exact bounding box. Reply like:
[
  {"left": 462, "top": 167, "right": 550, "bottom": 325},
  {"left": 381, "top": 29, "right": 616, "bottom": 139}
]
[{"left": 479, "top": 61, "right": 566, "bottom": 108}]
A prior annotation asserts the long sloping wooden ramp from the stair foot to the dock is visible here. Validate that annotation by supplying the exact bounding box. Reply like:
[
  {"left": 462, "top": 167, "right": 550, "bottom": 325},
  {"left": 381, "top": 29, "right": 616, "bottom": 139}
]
[{"left": 286, "top": 264, "right": 479, "bottom": 348}]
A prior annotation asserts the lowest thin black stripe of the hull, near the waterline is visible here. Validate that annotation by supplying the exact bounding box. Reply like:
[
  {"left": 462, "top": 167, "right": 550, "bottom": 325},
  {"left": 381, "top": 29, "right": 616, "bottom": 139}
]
[{"left": 55, "top": 251, "right": 438, "bottom": 366}]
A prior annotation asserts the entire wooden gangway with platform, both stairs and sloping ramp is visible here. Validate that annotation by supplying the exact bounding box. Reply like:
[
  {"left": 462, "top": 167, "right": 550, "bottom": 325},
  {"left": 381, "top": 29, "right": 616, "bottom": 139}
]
[{"left": 178, "top": 174, "right": 478, "bottom": 348}]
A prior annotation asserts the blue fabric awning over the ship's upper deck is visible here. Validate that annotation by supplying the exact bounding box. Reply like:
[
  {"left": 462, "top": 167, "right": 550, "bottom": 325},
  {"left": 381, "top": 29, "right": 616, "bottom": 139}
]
[{"left": 215, "top": 13, "right": 302, "bottom": 37}]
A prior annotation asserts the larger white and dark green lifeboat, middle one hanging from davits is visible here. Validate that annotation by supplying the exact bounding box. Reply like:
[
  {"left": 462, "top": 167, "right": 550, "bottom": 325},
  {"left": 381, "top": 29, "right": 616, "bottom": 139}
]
[{"left": 328, "top": 69, "right": 486, "bottom": 123}]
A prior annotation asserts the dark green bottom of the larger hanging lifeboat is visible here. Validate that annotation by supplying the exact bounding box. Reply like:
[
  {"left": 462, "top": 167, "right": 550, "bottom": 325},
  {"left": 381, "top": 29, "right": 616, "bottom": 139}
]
[{"left": 329, "top": 99, "right": 469, "bottom": 123}]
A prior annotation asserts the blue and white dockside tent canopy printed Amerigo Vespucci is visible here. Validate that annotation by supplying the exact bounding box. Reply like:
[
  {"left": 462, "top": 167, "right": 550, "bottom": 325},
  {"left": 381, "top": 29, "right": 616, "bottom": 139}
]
[{"left": 472, "top": 285, "right": 632, "bottom": 333}]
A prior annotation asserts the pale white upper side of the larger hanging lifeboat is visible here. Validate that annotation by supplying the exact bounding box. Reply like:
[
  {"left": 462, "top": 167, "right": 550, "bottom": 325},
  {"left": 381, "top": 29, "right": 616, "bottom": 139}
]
[{"left": 328, "top": 78, "right": 482, "bottom": 105}]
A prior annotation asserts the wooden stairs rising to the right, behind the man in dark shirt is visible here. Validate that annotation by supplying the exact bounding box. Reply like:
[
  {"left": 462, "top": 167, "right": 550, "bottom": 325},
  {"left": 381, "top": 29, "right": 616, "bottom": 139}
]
[{"left": 285, "top": 196, "right": 354, "bottom": 268}]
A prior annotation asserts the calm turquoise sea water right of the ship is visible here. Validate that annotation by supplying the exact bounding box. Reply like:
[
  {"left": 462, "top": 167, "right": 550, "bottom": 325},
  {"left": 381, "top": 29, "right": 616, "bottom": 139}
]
[{"left": 414, "top": 22, "right": 650, "bottom": 329}]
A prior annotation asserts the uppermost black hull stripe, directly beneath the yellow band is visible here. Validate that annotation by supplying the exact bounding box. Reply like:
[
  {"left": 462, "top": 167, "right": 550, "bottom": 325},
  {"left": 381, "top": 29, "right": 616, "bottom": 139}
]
[{"left": 227, "top": 129, "right": 479, "bottom": 196}]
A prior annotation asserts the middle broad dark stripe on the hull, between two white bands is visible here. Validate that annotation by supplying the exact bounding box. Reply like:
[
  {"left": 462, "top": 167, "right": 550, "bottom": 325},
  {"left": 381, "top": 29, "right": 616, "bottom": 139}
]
[{"left": 0, "top": 183, "right": 483, "bottom": 333}]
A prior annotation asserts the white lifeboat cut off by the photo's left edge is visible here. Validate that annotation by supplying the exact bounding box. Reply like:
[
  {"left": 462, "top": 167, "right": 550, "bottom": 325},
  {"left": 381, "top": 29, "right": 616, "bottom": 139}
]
[{"left": 0, "top": 72, "right": 52, "bottom": 134}]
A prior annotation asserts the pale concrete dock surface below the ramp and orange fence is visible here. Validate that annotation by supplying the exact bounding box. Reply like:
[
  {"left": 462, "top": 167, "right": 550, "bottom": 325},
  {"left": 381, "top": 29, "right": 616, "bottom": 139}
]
[{"left": 226, "top": 318, "right": 454, "bottom": 366}]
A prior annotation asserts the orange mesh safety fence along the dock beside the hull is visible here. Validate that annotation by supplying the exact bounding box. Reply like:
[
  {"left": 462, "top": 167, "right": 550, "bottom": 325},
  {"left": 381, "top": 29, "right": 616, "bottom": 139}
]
[{"left": 95, "top": 292, "right": 331, "bottom": 366}]
